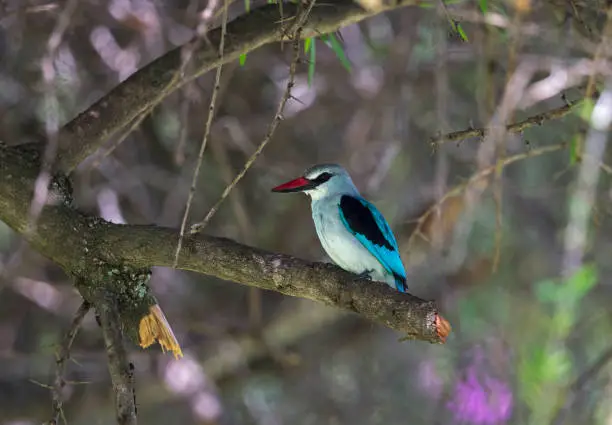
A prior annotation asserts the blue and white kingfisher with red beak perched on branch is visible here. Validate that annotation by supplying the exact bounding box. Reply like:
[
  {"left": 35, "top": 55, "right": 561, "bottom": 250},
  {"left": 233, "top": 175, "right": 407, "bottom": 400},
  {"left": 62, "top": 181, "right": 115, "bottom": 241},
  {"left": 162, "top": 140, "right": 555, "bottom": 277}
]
[{"left": 272, "top": 164, "right": 408, "bottom": 292}]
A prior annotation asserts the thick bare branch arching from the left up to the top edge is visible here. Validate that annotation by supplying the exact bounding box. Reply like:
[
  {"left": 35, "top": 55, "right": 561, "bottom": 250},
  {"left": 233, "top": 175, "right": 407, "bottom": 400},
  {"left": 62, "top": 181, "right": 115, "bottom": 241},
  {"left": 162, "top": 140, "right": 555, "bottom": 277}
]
[{"left": 51, "top": 0, "right": 416, "bottom": 174}]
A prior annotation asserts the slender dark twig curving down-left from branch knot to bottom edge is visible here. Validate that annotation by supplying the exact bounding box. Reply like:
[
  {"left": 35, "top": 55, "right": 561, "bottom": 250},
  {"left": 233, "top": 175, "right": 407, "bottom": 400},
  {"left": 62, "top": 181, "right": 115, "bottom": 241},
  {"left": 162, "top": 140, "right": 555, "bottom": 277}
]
[{"left": 49, "top": 301, "right": 91, "bottom": 425}]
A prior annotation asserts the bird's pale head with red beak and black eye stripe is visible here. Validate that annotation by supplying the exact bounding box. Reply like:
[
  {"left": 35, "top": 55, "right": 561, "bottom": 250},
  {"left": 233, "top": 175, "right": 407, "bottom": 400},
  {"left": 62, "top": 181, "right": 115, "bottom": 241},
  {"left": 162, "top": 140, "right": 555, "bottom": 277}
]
[{"left": 272, "top": 164, "right": 357, "bottom": 199}]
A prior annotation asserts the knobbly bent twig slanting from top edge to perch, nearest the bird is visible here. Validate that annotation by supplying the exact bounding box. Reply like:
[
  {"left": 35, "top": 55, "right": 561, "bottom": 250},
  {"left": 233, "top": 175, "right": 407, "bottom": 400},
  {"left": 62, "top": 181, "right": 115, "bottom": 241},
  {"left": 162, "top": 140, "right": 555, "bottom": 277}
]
[{"left": 190, "top": 0, "right": 315, "bottom": 234}]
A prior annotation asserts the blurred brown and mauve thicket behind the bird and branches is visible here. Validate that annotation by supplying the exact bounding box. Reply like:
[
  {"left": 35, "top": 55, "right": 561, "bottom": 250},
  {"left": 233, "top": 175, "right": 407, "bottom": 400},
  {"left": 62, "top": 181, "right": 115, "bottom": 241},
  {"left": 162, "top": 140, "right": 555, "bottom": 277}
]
[{"left": 0, "top": 0, "right": 612, "bottom": 425}]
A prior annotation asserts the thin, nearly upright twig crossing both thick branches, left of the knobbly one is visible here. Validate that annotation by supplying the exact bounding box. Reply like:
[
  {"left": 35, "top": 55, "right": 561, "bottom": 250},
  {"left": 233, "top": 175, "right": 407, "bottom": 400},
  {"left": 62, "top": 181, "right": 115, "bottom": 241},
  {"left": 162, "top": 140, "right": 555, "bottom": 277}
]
[{"left": 173, "top": 0, "right": 229, "bottom": 268}]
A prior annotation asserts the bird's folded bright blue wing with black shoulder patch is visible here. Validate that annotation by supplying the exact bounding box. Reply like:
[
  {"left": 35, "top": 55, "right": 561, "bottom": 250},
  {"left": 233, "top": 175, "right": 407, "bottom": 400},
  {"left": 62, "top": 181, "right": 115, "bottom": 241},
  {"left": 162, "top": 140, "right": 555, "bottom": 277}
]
[{"left": 338, "top": 195, "right": 407, "bottom": 292}]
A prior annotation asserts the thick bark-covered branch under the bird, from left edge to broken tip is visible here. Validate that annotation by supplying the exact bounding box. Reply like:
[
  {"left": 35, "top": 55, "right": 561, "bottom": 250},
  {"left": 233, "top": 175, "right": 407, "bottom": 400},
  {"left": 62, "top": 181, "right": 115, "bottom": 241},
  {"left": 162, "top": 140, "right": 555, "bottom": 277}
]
[{"left": 0, "top": 147, "right": 449, "bottom": 342}]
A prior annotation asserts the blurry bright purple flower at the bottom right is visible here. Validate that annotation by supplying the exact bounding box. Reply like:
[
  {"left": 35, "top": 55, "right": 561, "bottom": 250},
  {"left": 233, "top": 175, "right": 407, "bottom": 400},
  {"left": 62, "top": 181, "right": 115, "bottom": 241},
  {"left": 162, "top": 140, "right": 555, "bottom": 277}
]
[{"left": 447, "top": 366, "right": 512, "bottom": 425}]
